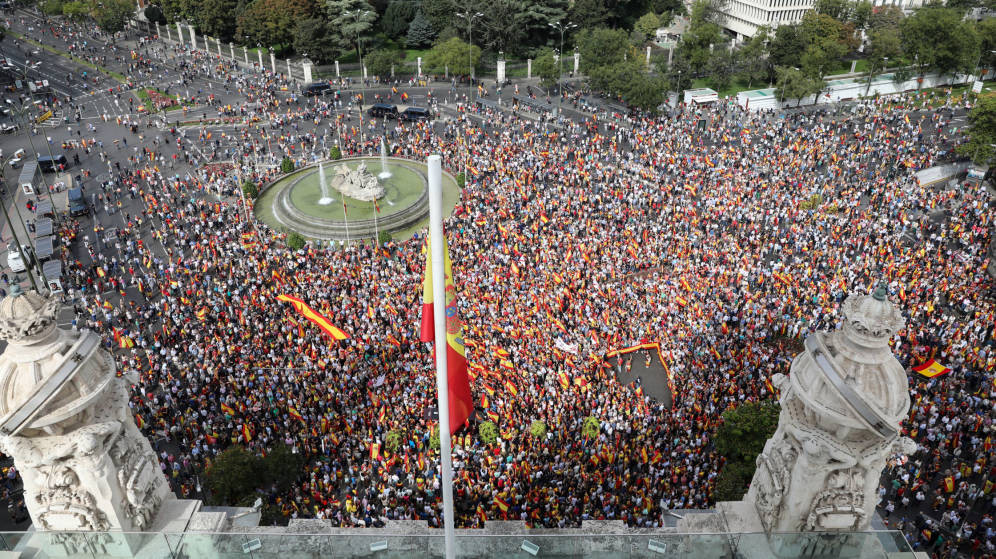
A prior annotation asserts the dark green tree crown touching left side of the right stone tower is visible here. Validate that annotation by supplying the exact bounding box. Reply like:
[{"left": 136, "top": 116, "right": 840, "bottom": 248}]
[{"left": 714, "top": 400, "right": 781, "bottom": 470}]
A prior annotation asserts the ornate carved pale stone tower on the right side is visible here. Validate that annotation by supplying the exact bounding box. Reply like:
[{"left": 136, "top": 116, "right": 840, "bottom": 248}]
[{"left": 744, "top": 287, "right": 916, "bottom": 532}]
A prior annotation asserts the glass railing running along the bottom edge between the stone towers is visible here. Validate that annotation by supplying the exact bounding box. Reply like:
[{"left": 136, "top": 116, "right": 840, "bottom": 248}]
[{"left": 0, "top": 528, "right": 912, "bottom": 559}]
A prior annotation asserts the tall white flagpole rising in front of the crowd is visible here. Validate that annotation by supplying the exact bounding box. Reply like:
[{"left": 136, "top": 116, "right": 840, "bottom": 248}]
[{"left": 429, "top": 154, "right": 456, "bottom": 559}]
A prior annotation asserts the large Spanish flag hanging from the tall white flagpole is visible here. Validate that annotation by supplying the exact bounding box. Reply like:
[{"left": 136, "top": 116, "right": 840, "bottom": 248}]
[{"left": 420, "top": 230, "right": 474, "bottom": 435}]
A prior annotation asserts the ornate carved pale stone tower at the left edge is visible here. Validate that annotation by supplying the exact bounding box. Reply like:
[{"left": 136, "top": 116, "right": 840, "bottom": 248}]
[{"left": 0, "top": 286, "right": 174, "bottom": 531}]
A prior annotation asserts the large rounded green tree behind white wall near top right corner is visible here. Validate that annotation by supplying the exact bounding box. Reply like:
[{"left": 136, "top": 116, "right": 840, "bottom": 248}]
[{"left": 900, "top": 4, "right": 981, "bottom": 74}]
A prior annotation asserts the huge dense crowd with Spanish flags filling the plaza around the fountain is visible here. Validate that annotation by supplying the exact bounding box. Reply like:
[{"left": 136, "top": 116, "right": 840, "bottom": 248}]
[{"left": 1, "top": 9, "right": 996, "bottom": 555}]
